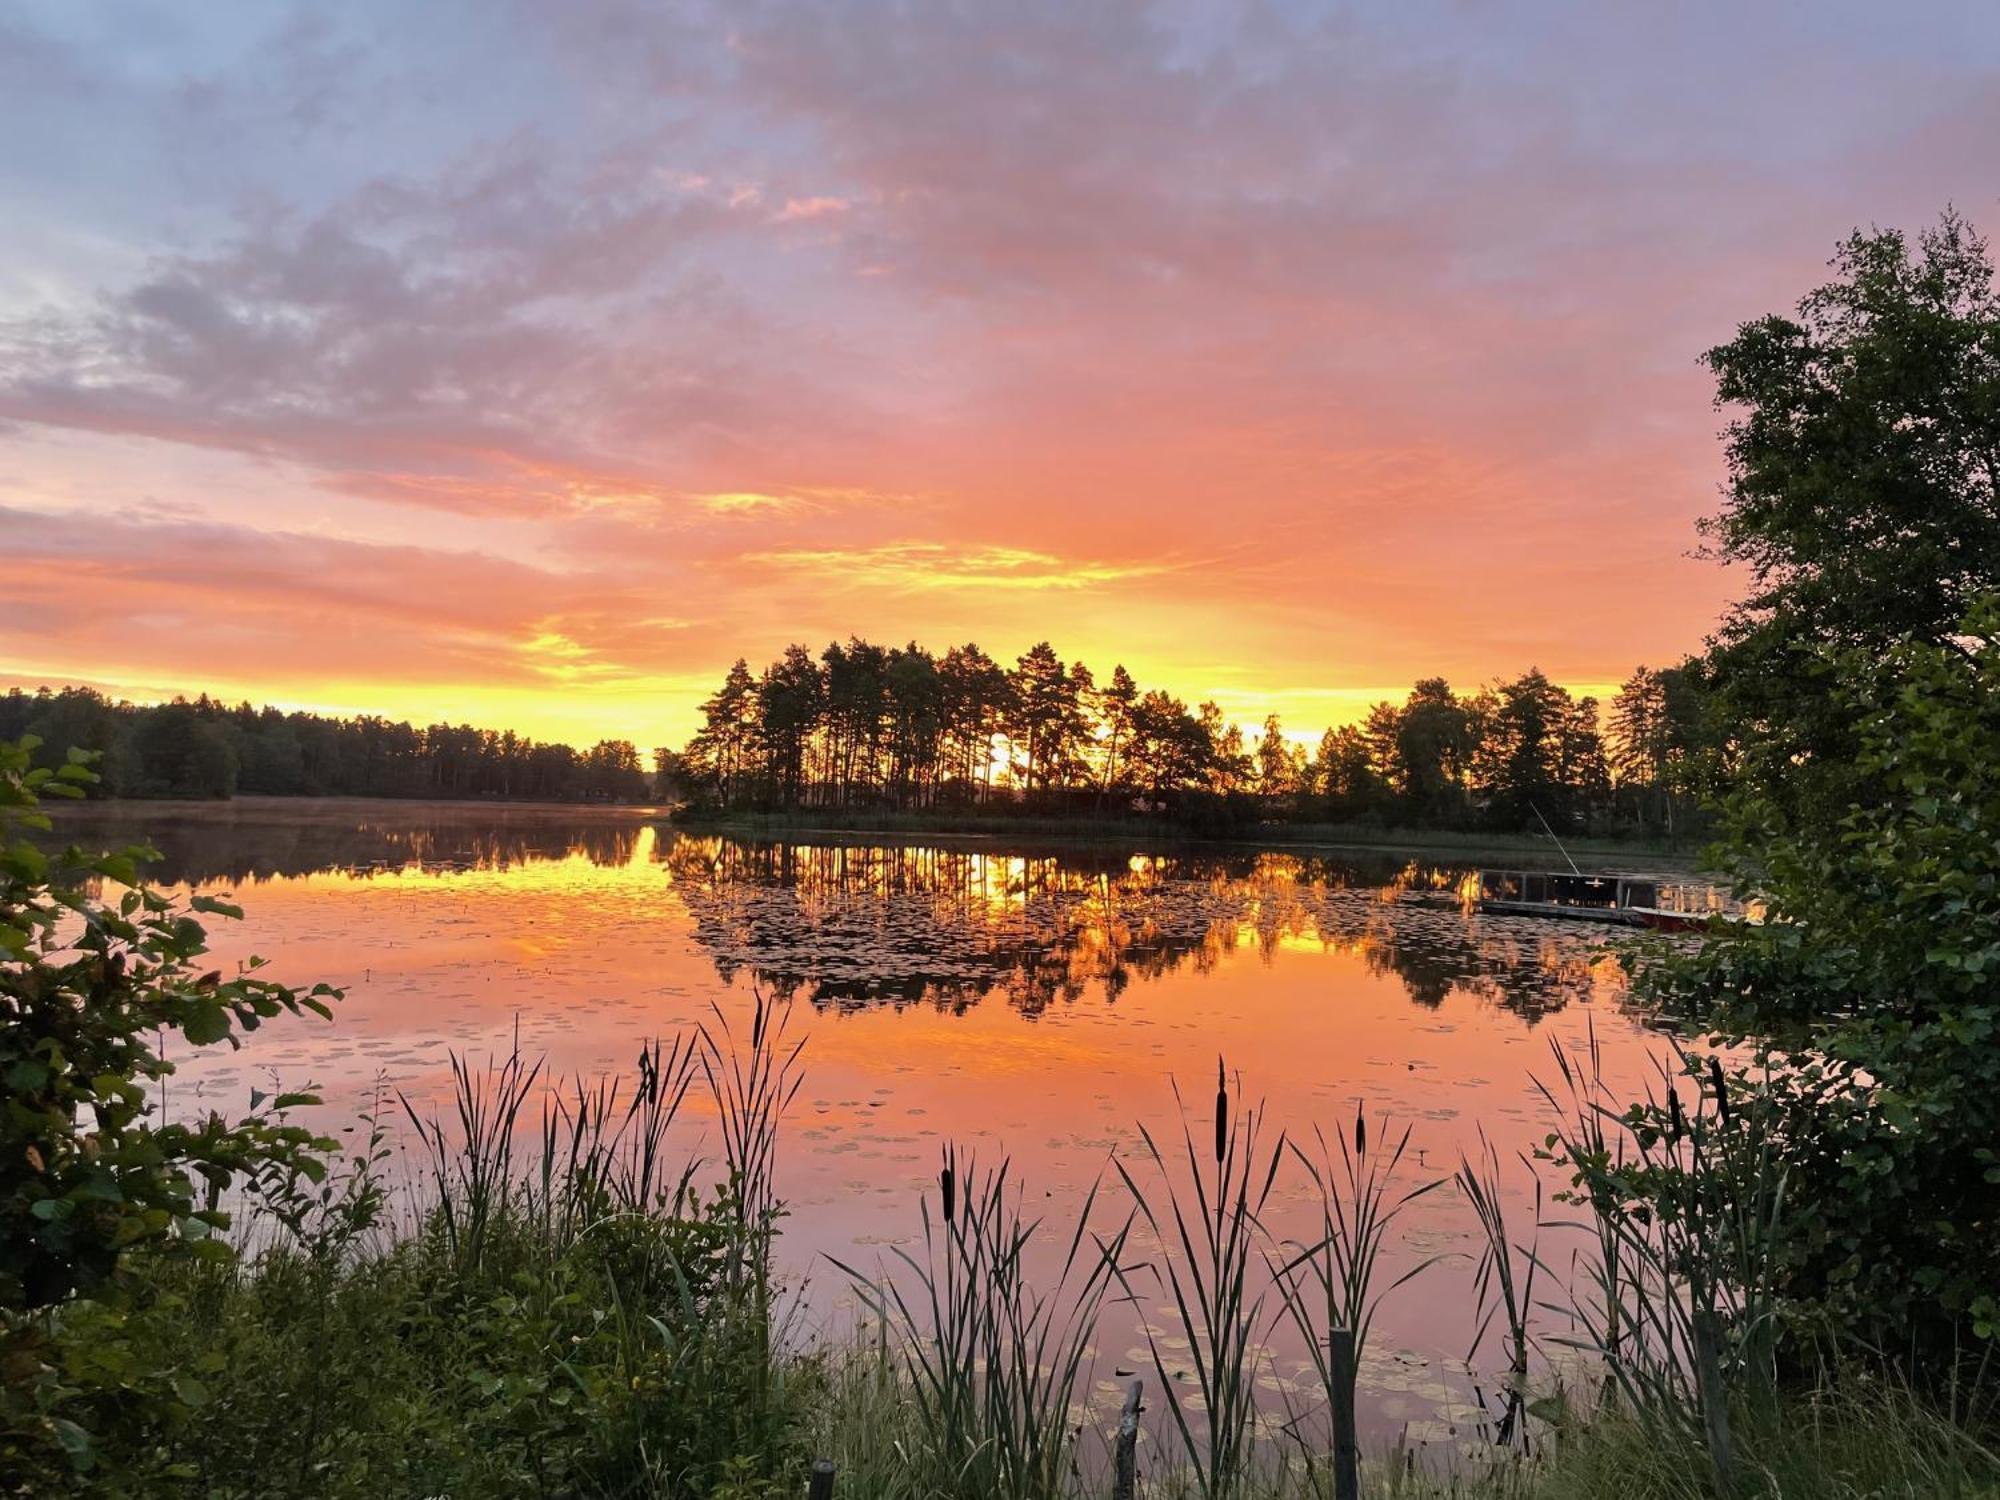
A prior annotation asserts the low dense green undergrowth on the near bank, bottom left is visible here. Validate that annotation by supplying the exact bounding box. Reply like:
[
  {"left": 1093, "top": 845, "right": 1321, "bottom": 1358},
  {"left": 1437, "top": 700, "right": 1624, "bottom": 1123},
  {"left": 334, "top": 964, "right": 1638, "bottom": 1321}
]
[{"left": 43, "top": 1204, "right": 802, "bottom": 1498}]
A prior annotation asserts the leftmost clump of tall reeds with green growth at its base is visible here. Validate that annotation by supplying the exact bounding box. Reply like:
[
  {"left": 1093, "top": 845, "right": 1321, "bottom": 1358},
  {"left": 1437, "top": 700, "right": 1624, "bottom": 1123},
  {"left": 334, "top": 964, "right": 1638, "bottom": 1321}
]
[{"left": 376, "top": 992, "right": 802, "bottom": 1494}]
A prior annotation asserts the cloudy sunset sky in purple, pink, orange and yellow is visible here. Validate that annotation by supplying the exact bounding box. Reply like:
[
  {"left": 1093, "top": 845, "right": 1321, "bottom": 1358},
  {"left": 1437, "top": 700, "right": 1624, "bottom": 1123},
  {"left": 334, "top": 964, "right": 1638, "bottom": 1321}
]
[{"left": 0, "top": 0, "right": 2000, "bottom": 748}]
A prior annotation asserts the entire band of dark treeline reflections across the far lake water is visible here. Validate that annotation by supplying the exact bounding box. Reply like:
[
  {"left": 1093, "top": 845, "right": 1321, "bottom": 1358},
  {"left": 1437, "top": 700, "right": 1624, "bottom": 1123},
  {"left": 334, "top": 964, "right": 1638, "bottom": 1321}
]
[{"left": 47, "top": 800, "right": 1632, "bottom": 1022}]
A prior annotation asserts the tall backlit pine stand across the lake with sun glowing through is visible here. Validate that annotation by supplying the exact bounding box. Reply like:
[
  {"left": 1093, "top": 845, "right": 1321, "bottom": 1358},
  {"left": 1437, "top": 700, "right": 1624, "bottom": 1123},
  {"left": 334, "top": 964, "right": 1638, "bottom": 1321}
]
[{"left": 660, "top": 638, "right": 1704, "bottom": 836}]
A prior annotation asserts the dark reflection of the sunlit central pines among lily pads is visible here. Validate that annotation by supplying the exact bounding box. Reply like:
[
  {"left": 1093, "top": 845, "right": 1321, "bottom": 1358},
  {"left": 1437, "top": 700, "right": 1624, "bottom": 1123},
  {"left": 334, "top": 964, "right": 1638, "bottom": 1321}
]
[{"left": 666, "top": 838, "right": 1596, "bottom": 1020}]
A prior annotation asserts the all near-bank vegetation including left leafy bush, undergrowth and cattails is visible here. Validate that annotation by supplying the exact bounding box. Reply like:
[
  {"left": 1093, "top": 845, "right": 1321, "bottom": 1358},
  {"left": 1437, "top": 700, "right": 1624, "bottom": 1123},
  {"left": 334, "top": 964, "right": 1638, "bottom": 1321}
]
[{"left": 0, "top": 746, "right": 2000, "bottom": 1500}]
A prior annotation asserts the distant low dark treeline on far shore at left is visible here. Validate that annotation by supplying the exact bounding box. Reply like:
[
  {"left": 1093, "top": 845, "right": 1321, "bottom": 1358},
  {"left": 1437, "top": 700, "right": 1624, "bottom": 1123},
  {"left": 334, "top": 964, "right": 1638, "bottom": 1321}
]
[{"left": 0, "top": 688, "right": 652, "bottom": 802}]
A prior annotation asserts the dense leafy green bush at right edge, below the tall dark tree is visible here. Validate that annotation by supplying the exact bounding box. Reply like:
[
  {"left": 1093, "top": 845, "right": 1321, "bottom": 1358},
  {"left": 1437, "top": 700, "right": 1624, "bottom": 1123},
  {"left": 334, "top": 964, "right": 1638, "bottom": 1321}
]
[{"left": 1642, "top": 598, "right": 2000, "bottom": 1370}]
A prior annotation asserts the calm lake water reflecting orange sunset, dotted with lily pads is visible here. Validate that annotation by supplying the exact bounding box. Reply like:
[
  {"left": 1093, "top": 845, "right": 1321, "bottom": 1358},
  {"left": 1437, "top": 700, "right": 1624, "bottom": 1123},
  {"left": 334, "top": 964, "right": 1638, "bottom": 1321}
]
[{"left": 50, "top": 802, "right": 1688, "bottom": 1440}]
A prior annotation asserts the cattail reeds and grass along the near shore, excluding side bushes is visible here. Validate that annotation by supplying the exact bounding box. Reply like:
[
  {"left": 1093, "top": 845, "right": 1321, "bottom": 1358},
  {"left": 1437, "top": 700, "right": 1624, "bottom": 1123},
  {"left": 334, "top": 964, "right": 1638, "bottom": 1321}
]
[{"left": 47, "top": 996, "right": 2000, "bottom": 1500}]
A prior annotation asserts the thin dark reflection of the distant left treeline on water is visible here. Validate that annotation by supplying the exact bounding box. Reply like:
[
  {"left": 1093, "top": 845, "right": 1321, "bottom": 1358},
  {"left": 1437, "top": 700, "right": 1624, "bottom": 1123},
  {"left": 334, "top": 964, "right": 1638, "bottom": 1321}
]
[{"left": 52, "top": 808, "right": 644, "bottom": 886}]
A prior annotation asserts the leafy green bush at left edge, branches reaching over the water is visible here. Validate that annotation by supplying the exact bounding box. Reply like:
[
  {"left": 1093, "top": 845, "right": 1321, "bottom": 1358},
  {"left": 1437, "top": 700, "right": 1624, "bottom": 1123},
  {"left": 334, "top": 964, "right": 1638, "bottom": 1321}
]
[{"left": 0, "top": 738, "right": 338, "bottom": 1468}]
